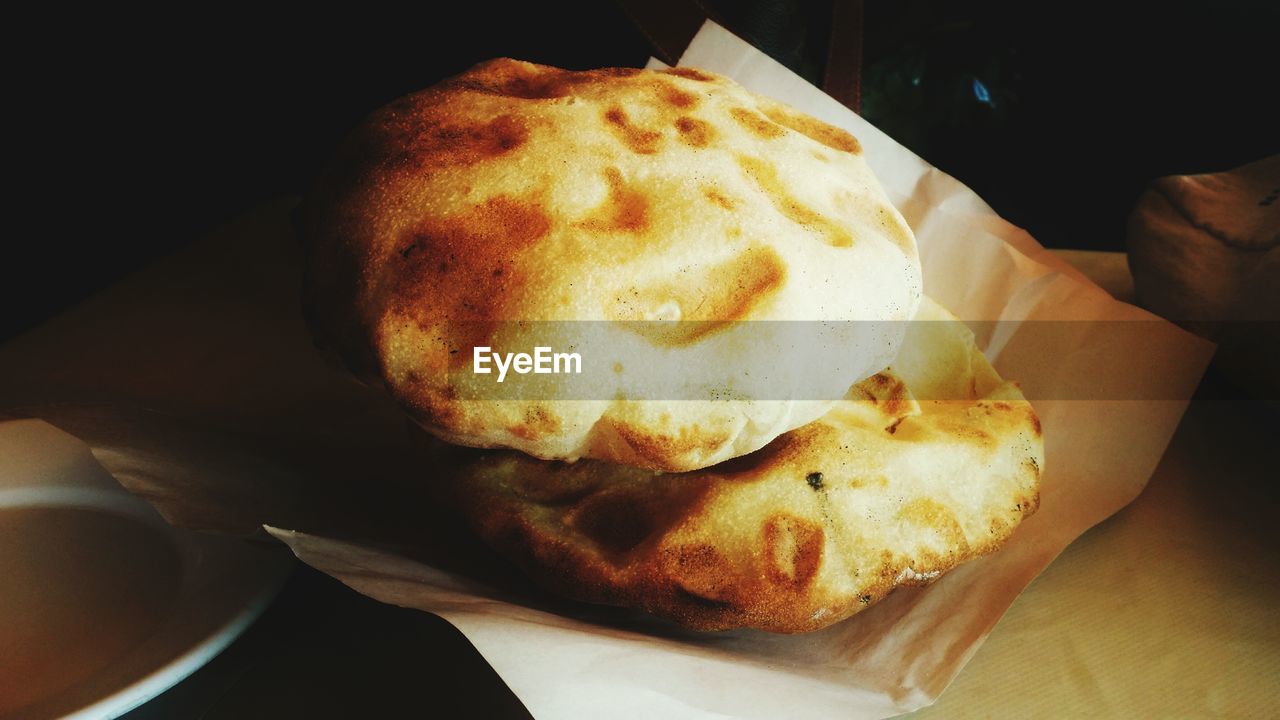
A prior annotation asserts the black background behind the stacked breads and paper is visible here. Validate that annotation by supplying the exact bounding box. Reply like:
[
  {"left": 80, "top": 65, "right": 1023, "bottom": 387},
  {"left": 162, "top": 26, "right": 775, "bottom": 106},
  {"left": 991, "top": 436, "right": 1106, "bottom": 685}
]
[{"left": 0, "top": 0, "right": 1280, "bottom": 340}]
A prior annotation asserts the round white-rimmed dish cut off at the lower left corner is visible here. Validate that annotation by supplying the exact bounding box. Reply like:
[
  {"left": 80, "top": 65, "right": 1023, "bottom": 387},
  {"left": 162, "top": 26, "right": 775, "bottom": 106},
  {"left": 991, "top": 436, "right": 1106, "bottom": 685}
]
[{"left": 0, "top": 420, "right": 294, "bottom": 720}]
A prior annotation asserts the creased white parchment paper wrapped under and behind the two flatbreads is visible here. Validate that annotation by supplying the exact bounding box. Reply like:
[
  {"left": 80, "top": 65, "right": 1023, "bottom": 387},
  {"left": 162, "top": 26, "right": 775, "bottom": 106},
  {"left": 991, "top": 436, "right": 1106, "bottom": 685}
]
[{"left": 0, "top": 23, "right": 1212, "bottom": 719}]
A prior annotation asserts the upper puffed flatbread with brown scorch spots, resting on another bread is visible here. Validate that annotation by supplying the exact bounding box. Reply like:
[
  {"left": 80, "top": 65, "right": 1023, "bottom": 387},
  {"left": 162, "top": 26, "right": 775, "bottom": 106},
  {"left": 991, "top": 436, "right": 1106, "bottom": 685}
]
[{"left": 300, "top": 60, "right": 922, "bottom": 471}]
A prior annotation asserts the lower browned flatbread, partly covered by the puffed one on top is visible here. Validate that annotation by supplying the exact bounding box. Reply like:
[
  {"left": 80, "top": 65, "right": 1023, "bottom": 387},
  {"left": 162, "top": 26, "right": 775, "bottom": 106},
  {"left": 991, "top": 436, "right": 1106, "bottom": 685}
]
[{"left": 436, "top": 300, "right": 1044, "bottom": 633}]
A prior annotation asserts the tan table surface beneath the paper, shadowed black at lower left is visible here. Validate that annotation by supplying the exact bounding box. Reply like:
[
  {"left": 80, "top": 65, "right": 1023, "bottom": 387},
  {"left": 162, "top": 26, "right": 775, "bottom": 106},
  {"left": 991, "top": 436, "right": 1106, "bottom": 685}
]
[{"left": 10, "top": 202, "right": 1280, "bottom": 720}]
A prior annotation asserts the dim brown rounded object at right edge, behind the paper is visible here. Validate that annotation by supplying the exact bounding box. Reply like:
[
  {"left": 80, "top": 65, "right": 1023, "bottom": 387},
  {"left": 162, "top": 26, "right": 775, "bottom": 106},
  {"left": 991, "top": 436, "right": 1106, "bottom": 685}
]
[{"left": 1129, "top": 155, "right": 1280, "bottom": 401}]
